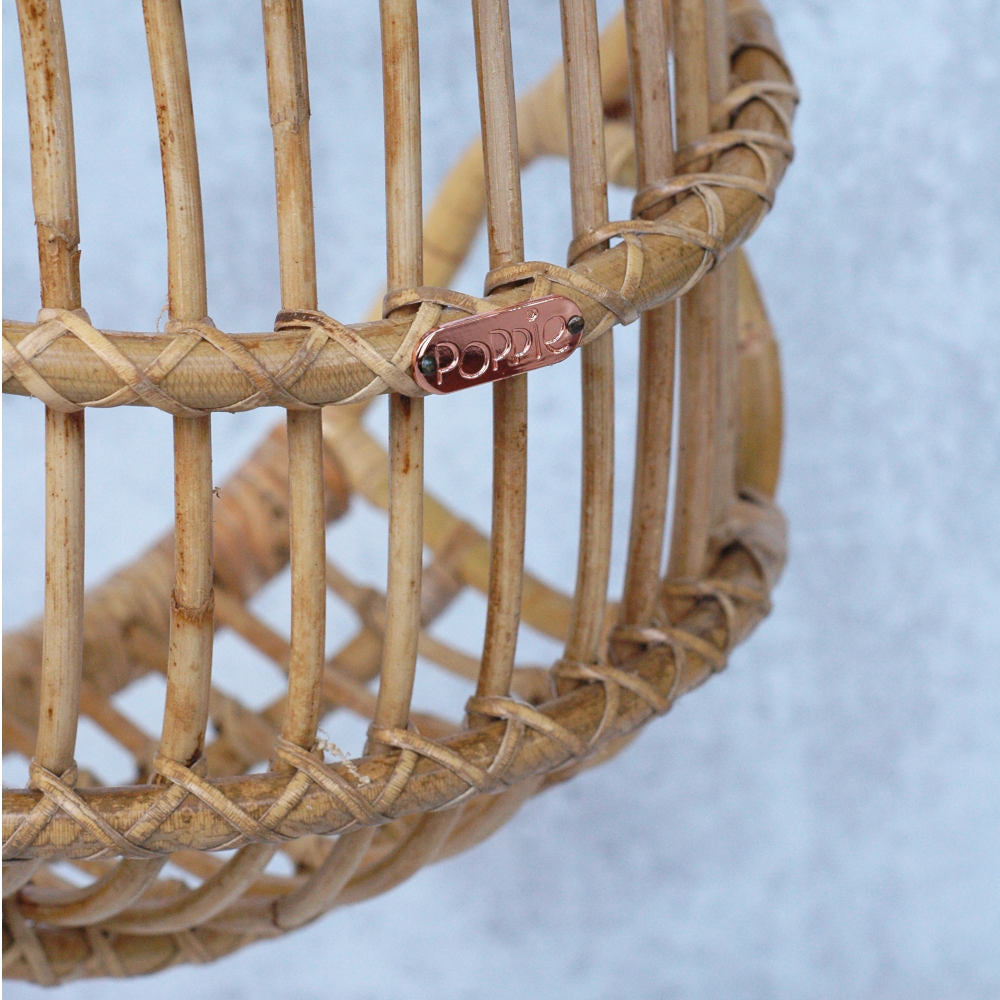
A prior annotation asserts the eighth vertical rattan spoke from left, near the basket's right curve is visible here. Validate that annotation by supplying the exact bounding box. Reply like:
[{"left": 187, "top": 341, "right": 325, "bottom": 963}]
[{"left": 669, "top": 0, "right": 719, "bottom": 579}]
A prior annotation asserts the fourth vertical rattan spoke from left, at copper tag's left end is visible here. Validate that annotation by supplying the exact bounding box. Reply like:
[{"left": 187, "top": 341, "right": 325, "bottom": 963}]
[{"left": 368, "top": 0, "right": 424, "bottom": 752}]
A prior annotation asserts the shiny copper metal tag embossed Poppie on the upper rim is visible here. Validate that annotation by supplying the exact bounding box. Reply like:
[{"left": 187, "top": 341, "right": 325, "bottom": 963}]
[{"left": 413, "top": 295, "right": 584, "bottom": 393}]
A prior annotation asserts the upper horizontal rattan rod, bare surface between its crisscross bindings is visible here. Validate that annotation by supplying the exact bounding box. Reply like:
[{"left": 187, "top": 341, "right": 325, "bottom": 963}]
[{"left": 4, "top": 18, "right": 794, "bottom": 408}]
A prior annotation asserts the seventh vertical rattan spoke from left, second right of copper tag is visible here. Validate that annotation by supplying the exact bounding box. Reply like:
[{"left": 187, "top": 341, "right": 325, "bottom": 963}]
[{"left": 621, "top": 0, "right": 676, "bottom": 624}]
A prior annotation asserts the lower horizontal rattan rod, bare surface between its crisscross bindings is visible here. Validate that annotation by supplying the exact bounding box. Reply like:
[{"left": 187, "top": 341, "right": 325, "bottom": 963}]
[{"left": 3, "top": 505, "right": 785, "bottom": 857}]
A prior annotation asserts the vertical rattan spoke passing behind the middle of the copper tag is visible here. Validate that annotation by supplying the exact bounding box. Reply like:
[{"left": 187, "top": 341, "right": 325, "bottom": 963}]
[{"left": 472, "top": 0, "right": 528, "bottom": 716}]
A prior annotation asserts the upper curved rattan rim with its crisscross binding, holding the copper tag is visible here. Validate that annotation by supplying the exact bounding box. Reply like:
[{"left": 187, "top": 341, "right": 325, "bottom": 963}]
[{"left": 3, "top": 9, "right": 796, "bottom": 416}]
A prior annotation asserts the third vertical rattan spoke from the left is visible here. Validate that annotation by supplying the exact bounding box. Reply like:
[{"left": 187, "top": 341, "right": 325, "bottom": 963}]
[{"left": 263, "top": 0, "right": 326, "bottom": 766}]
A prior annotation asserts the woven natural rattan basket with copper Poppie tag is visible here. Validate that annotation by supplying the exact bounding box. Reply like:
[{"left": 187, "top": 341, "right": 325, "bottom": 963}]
[{"left": 3, "top": 0, "right": 795, "bottom": 983}]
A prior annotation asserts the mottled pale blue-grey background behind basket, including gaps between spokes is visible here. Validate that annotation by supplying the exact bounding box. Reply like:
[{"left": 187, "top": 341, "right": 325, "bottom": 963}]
[{"left": 3, "top": 0, "right": 1000, "bottom": 1000}]
